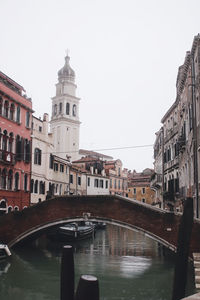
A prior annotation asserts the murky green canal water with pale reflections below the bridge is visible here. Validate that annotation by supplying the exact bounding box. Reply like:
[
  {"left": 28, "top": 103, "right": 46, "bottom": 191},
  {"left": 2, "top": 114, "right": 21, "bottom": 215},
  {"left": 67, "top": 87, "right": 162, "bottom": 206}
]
[{"left": 0, "top": 225, "right": 195, "bottom": 300}]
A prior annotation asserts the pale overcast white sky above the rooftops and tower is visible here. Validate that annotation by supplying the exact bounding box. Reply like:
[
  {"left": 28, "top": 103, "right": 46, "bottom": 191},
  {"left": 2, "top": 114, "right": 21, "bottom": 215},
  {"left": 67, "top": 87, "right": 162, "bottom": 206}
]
[{"left": 0, "top": 0, "right": 200, "bottom": 172}]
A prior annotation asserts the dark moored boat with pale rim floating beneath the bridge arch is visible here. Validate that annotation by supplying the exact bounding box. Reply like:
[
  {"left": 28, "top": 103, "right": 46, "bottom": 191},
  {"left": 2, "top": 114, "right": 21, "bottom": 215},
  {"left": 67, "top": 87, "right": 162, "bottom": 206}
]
[{"left": 56, "top": 221, "right": 95, "bottom": 241}]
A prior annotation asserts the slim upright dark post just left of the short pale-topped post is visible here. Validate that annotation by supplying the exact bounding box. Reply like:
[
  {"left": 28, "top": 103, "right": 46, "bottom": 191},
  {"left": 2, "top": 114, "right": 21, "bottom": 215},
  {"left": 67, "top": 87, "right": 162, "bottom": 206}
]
[{"left": 60, "top": 246, "right": 74, "bottom": 300}]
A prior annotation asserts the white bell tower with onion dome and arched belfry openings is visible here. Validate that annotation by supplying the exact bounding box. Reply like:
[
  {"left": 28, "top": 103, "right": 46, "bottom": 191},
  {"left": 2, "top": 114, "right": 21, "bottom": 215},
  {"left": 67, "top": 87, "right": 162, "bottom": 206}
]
[{"left": 50, "top": 55, "right": 80, "bottom": 161}]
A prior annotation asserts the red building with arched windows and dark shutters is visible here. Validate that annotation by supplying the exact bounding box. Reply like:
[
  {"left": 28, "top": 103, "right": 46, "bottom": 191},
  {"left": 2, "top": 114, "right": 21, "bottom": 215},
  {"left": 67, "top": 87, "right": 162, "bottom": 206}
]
[{"left": 0, "top": 72, "right": 33, "bottom": 213}]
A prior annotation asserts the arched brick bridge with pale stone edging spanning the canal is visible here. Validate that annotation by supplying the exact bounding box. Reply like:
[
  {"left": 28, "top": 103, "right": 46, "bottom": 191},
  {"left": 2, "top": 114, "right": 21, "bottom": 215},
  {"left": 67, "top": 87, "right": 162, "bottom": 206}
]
[{"left": 0, "top": 195, "right": 200, "bottom": 254}]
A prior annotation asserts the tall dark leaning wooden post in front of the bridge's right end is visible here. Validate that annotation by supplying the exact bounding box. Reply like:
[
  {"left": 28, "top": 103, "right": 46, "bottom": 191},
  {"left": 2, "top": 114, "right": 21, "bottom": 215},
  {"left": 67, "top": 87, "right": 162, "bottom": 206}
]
[{"left": 172, "top": 198, "right": 194, "bottom": 300}]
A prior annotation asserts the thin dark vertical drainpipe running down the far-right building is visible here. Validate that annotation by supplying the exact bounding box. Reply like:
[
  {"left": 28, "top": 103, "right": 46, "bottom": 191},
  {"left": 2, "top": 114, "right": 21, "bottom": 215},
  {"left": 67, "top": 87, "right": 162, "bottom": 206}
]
[{"left": 191, "top": 56, "right": 199, "bottom": 218}]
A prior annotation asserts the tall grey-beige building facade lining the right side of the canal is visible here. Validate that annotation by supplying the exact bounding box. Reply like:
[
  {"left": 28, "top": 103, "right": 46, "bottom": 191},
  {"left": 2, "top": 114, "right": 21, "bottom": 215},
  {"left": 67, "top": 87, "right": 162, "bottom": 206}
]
[{"left": 154, "top": 34, "right": 200, "bottom": 218}]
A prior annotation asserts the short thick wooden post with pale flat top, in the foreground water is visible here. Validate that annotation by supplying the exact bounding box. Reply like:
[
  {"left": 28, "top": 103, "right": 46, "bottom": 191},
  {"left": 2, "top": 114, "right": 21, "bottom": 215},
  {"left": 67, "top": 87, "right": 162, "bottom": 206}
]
[{"left": 75, "top": 275, "right": 99, "bottom": 300}]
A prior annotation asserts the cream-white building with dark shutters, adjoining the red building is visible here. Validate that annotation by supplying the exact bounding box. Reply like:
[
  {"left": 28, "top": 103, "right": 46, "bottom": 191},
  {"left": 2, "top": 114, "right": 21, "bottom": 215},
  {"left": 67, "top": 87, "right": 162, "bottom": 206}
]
[{"left": 31, "top": 114, "right": 70, "bottom": 204}]
